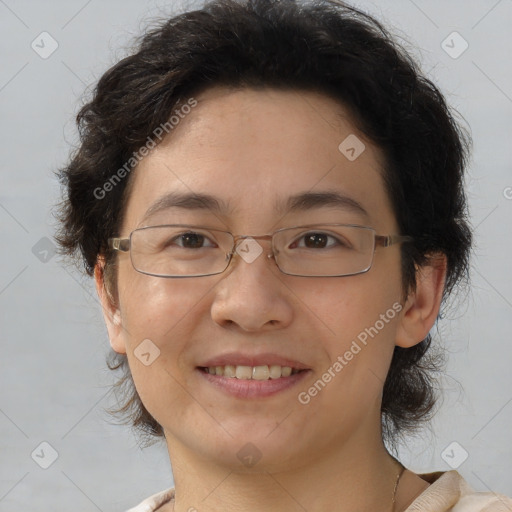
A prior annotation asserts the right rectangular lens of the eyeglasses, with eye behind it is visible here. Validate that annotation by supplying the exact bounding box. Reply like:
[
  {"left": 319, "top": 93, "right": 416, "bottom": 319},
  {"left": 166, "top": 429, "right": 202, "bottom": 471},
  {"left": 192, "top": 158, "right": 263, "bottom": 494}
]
[{"left": 274, "top": 224, "right": 375, "bottom": 277}]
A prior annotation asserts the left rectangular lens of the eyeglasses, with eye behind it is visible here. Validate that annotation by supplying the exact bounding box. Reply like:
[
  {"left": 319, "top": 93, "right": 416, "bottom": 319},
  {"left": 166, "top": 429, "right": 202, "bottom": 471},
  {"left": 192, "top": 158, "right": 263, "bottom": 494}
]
[{"left": 130, "top": 225, "right": 233, "bottom": 277}]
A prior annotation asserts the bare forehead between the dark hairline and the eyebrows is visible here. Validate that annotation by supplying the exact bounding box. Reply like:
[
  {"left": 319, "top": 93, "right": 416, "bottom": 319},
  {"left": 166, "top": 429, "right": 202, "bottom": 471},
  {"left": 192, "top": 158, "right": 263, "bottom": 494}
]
[{"left": 120, "top": 87, "right": 394, "bottom": 231}]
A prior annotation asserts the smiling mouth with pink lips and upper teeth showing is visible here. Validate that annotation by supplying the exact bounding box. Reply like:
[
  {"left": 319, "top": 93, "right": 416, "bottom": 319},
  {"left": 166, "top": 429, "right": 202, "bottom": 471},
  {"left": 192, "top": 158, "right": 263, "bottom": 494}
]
[{"left": 196, "top": 354, "right": 311, "bottom": 399}]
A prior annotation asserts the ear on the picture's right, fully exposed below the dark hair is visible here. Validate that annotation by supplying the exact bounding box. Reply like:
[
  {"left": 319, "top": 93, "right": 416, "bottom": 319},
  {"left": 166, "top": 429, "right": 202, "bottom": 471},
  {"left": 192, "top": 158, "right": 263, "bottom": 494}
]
[{"left": 396, "top": 253, "right": 447, "bottom": 348}]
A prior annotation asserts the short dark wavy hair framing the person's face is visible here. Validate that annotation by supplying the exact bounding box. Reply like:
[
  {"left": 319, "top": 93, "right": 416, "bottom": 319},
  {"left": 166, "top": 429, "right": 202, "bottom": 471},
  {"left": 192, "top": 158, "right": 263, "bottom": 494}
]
[{"left": 55, "top": 0, "right": 471, "bottom": 446}]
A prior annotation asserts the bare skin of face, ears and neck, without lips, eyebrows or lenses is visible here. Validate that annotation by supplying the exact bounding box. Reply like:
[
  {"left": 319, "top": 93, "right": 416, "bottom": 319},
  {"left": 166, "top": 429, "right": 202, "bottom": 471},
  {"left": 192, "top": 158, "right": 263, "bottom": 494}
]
[{"left": 96, "top": 87, "right": 446, "bottom": 512}]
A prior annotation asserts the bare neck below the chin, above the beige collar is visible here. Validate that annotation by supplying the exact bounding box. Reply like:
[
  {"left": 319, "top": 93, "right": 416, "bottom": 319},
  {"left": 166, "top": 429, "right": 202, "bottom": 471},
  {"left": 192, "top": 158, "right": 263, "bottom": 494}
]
[{"left": 167, "top": 424, "right": 402, "bottom": 512}]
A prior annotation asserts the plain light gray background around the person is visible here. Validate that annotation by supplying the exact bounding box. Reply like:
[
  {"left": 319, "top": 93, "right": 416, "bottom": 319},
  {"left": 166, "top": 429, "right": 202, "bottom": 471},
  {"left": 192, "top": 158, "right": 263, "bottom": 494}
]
[{"left": 0, "top": 0, "right": 512, "bottom": 512}]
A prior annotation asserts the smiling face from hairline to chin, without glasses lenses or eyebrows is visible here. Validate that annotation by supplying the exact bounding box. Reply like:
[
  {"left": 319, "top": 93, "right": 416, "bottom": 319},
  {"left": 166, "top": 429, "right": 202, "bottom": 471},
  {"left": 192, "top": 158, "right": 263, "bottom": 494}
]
[{"left": 105, "top": 88, "right": 408, "bottom": 471}]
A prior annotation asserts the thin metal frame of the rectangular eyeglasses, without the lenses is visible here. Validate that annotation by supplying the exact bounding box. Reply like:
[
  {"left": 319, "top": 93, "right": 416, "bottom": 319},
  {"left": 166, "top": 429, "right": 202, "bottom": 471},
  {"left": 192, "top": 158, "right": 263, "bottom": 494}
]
[{"left": 108, "top": 223, "right": 414, "bottom": 279}]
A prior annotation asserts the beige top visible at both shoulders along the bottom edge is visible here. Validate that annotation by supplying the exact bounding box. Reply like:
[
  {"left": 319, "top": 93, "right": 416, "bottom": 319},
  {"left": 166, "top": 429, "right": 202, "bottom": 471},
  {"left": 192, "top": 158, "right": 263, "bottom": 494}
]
[{"left": 127, "top": 471, "right": 512, "bottom": 512}]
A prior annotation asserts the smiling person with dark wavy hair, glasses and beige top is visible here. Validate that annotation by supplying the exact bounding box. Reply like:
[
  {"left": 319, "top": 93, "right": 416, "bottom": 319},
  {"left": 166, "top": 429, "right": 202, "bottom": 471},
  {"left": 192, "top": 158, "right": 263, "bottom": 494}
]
[{"left": 58, "top": 0, "right": 512, "bottom": 512}]
